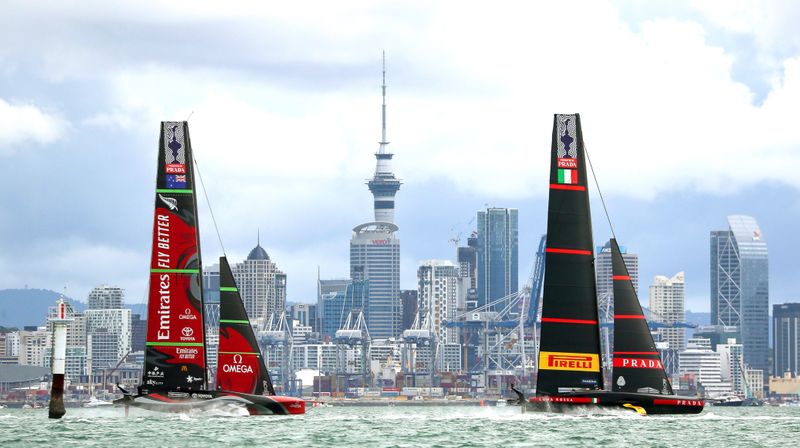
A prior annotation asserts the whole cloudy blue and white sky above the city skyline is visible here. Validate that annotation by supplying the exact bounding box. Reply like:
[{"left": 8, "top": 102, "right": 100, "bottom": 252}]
[{"left": 0, "top": 0, "right": 800, "bottom": 312}]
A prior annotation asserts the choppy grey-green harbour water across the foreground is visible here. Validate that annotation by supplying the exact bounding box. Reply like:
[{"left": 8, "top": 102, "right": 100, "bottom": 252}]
[{"left": 0, "top": 406, "right": 800, "bottom": 448}]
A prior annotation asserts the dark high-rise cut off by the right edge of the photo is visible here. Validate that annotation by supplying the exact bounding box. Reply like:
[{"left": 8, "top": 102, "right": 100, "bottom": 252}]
[{"left": 772, "top": 303, "right": 800, "bottom": 377}]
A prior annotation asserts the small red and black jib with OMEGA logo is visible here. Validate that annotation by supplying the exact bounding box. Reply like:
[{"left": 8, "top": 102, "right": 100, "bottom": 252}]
[{"left": 217, "top": 257, "right": 275, "bottom": 395}]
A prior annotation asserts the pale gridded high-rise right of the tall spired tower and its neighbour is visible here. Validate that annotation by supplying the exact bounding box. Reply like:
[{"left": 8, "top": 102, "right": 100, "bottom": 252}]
[{"left": 417, "top": 260, "right": 460, "bottom": 344}]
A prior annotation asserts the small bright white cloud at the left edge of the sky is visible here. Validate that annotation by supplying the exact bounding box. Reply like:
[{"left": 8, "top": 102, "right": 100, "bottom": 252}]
[{"left": 0, "top": 98, "right": 68, "bottom": 155}]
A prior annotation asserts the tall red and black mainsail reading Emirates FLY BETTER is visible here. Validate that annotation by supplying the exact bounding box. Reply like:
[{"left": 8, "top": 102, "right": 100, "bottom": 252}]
[{"left": 142, "top": 121, "right": 206, "bottom": 391}]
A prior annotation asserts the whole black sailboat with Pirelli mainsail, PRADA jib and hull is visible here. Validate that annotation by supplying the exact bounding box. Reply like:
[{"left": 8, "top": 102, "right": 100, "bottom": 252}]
[{"left": 527, "top": 114, "right": 703, "bottom": 414}]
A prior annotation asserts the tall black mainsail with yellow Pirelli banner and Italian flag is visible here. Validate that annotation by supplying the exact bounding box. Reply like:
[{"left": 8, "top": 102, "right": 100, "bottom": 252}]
[{"left": 536, "top": 114, "right": 603, "bottom": 395}]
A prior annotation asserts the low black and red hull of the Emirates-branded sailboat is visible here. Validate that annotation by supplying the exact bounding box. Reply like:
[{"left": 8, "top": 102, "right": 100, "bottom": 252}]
[{"left": 114, "top": 391, "right": 305, "bottom": 415}]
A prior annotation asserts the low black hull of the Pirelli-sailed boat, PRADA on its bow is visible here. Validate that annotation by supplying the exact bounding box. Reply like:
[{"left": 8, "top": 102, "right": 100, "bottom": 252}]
[{"left": 525, "top": 391, "right": 704, "bottom": 415}]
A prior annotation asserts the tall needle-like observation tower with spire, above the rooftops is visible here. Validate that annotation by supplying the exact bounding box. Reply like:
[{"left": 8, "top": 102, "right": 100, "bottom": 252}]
[{"left": 367, "top": 52, "right": 401, "bottom": 223}]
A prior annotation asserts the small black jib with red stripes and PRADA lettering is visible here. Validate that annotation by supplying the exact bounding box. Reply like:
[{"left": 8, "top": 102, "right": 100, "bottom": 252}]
[{"left": 611, "top": 239, "right": 673, "bottom": 395}]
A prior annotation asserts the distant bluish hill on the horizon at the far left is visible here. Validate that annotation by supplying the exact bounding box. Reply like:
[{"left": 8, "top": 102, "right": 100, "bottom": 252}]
[{"left": 0, "top": 289, "right": 86, "bottom": 328}]
